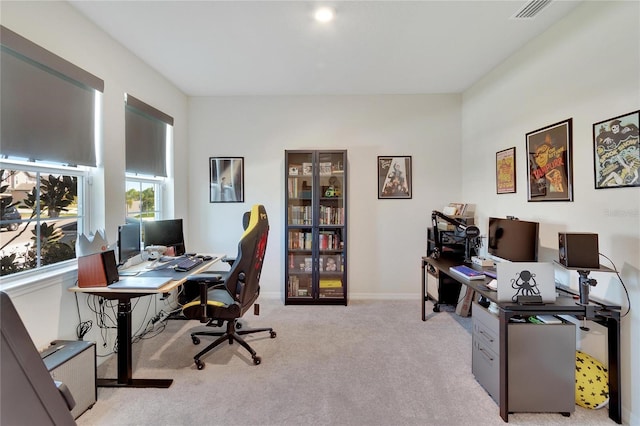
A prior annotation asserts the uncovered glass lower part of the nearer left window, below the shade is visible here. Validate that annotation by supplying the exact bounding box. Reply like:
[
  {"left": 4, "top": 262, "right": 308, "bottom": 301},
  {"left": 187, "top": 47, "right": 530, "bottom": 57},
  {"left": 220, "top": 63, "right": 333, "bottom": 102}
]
[{"left": 0, "top": 160, "right": 87, "bottom": 276}]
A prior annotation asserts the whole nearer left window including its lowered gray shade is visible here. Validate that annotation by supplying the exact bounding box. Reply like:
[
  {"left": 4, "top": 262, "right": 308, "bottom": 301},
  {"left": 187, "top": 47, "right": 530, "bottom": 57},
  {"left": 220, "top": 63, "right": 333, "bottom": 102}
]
[{"left": 0, "top": 26, "right": 104, "bottom": 276}]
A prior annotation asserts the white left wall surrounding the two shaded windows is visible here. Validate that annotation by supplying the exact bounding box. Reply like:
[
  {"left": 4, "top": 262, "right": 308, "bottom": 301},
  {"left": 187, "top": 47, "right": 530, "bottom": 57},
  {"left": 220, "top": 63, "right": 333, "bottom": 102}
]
[{"left": 0, "top": 1, "right": 188, "bottom": 354}]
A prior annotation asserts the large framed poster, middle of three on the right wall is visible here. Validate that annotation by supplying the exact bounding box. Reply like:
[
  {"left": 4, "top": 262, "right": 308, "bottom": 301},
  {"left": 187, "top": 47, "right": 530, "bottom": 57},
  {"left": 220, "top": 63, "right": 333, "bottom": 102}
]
[{"left": 527, "top": 118, "right": 573, "bottom": 201}]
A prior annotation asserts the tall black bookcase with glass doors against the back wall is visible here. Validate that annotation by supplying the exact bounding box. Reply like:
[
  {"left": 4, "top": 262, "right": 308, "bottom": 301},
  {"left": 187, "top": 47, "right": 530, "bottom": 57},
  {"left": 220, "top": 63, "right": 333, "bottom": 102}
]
[{"left": 285, "top": 150, "right": 347, "bottom": 306}]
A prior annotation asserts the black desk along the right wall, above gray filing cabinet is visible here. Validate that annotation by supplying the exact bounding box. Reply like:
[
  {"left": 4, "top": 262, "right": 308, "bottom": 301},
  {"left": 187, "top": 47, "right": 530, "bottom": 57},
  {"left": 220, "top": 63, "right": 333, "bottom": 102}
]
[{"left": 421, "top": 256, "right": 622, "bottom": 424}]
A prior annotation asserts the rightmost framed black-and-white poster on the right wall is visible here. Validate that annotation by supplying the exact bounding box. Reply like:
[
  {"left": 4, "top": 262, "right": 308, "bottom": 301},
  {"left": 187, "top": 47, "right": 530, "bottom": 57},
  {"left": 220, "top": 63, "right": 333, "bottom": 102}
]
[{"left": 593, "top": 111, "right": 640, "bottom": 189}]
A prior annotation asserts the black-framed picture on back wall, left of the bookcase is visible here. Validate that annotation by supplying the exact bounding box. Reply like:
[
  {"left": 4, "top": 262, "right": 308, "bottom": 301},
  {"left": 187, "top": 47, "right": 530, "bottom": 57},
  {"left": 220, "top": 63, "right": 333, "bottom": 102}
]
[{"left": 209, "top": 157, "right": 244, "bottom": 203}]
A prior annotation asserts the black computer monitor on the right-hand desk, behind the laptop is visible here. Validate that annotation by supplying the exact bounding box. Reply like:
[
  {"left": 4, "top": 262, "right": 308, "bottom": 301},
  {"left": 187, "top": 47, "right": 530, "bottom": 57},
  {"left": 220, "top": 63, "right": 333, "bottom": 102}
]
[{"left": 487, "top": 217, "right": 539, "bottom": 262}]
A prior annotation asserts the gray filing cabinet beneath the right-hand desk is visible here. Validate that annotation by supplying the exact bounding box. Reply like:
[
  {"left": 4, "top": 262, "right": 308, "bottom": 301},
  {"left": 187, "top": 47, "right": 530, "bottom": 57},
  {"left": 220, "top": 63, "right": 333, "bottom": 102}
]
[{"left": 472, "top": 302, "right": 576, "bottom": 413}]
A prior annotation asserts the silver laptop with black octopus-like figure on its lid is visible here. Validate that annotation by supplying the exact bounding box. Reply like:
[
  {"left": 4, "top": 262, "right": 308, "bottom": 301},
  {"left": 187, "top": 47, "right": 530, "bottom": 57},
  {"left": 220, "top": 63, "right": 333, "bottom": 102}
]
[{"left": 496, "top": 262, "right": 556, "bottom": 303}]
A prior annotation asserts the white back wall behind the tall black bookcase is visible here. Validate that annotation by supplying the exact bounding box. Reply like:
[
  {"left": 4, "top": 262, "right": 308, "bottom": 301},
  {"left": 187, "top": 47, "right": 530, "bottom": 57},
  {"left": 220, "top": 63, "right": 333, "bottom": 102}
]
[{"left": 189, "top": 95, "right": 461, "bottom": 300}]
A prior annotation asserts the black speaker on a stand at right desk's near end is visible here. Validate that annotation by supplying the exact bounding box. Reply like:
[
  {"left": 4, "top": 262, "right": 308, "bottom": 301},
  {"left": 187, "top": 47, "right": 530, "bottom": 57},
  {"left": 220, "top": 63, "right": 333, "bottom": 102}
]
[{"left": 558, "top": 232, "right": 600, "bottom": 269}]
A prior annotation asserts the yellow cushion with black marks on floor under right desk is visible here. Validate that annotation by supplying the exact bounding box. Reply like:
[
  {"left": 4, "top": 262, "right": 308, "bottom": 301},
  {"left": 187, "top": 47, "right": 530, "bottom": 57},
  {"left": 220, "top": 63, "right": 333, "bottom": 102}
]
[{"left": 576, "top": 351, "right": 609, "bottom": 410}]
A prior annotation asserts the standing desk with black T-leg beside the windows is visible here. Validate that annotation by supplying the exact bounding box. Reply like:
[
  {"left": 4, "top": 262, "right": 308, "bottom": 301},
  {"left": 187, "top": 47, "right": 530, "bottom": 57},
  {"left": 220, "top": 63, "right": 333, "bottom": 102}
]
[{"left": 69, "top": 254, "right": 223, "bottom": 388}]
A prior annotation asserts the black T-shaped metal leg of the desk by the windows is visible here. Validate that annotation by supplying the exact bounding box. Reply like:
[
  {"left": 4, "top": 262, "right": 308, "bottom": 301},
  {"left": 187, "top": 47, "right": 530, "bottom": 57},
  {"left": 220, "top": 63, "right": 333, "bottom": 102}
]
[{"left": 96, "top": 298, "right": 173, "bottom": 388}]
